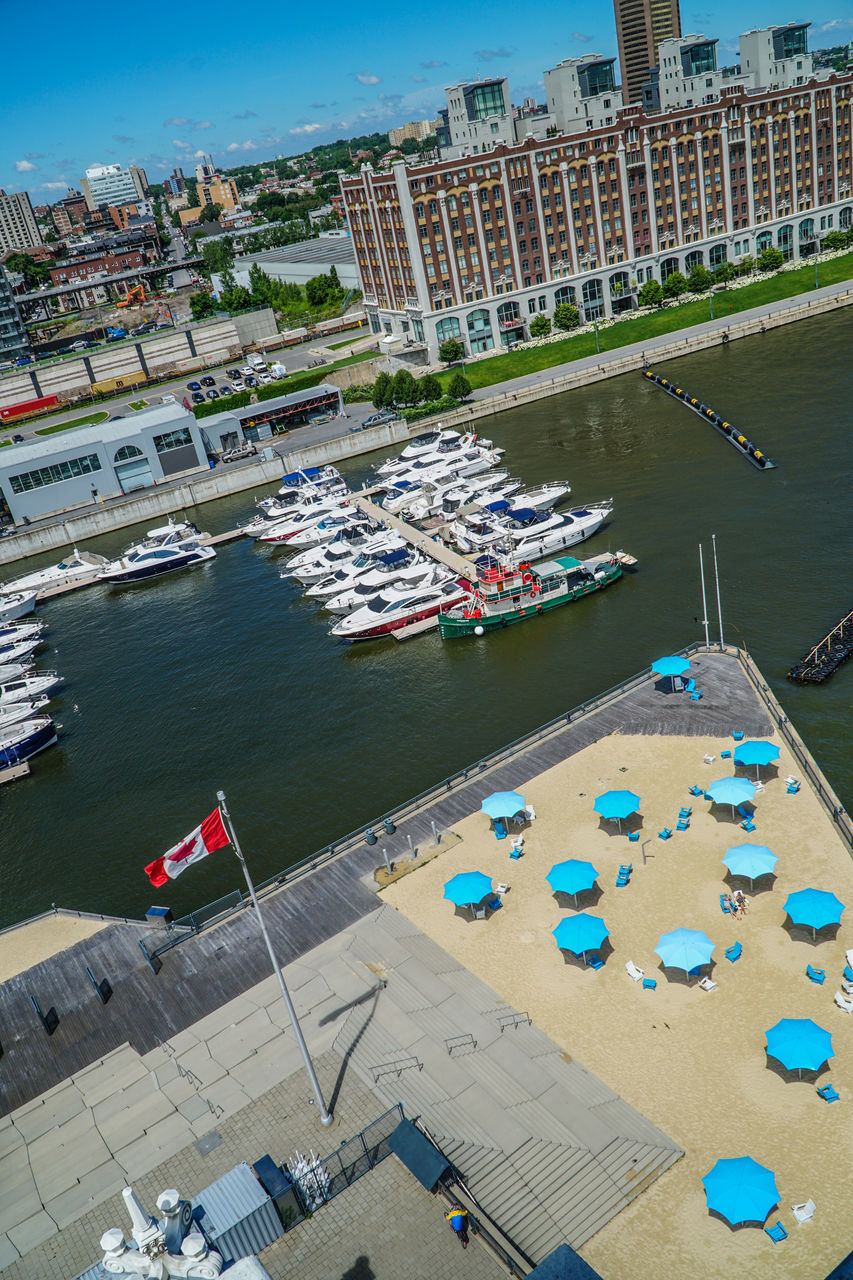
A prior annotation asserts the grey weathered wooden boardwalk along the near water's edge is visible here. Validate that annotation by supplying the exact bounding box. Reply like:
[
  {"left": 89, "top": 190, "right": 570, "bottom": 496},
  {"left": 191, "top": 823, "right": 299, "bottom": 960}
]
[{"left": 0, "top": 654, "right": 771, "bottom": 1114}]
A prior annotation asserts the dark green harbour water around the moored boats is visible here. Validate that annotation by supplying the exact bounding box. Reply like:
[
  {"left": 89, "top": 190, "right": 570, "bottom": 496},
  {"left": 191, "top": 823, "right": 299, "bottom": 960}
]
[{"left": 0, "top": 310, "right": 853, "bottom": 923}]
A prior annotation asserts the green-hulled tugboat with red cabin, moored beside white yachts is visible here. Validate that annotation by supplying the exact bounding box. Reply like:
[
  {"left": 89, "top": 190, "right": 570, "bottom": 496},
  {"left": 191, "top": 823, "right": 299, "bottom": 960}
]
[{"left": 438, "top": 553, "right": 622, "bottom": 640}]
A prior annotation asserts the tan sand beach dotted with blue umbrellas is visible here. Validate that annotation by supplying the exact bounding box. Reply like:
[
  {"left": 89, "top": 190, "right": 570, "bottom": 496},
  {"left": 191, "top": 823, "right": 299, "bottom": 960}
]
[{"left": 383, "top": 735, "right": 853, "bottom": 1280}]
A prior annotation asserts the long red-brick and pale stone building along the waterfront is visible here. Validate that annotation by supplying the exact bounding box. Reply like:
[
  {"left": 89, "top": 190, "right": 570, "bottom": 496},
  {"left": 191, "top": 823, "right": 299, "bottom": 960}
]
[{"left": 341, "top": 72, "right": 853, "bottom": 355}]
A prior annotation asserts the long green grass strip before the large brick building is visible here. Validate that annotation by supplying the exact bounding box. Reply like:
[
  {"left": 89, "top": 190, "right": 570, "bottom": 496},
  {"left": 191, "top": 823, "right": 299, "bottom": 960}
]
[{"left": 438, "top": 253, "right": 853, "bottom": 387}]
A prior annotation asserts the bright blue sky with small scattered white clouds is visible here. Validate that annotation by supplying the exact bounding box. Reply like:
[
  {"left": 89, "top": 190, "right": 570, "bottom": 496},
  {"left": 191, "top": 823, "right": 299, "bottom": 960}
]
[{"left": 0, "top": 0, "right": 853, "bottom": 197}]
